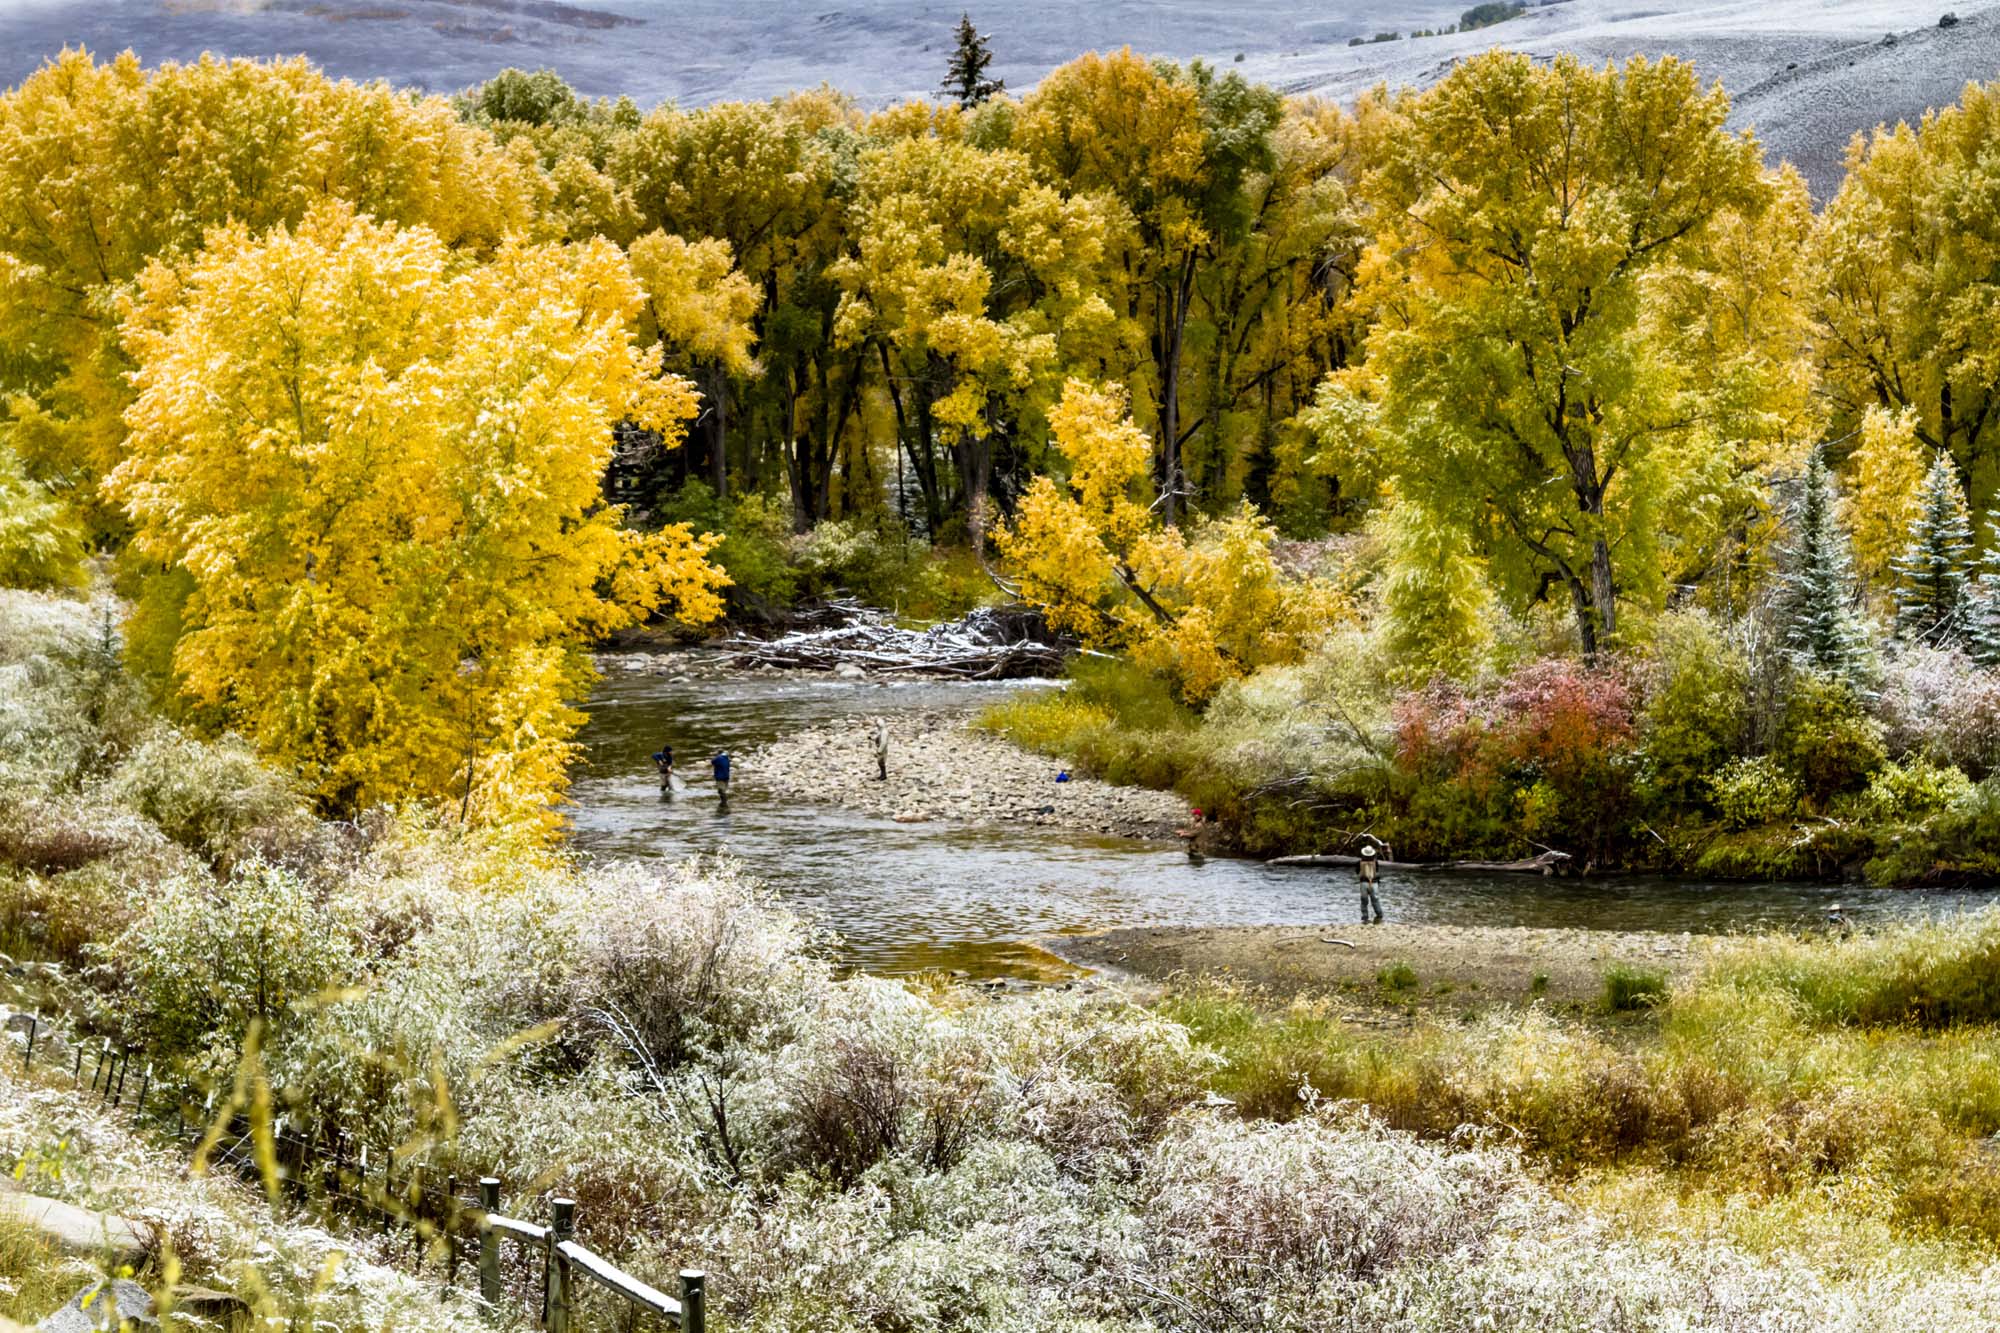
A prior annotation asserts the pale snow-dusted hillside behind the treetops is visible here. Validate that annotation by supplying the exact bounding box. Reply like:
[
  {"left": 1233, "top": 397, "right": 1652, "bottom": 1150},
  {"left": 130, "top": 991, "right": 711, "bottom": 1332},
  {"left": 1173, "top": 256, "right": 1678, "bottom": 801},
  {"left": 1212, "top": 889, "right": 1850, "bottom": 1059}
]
[{"left": 0, "top": 0, "right": 2000, "bottom": 198}]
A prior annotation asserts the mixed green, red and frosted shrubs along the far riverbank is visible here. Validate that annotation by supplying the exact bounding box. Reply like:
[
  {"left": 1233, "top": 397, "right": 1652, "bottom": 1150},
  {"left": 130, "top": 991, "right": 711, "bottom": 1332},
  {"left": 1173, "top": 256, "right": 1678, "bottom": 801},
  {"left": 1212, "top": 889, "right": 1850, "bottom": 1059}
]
[{"left": 984, "top": 612, "right": 2000, "bottom": 885}]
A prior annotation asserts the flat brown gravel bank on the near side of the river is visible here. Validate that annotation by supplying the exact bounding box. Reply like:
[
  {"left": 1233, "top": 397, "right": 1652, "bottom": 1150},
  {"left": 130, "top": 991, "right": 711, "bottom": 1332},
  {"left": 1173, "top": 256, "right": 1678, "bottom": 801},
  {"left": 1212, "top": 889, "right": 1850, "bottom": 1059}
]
[{"left": 1042, "top": 923, "right": 1708, "bottom": 1007}]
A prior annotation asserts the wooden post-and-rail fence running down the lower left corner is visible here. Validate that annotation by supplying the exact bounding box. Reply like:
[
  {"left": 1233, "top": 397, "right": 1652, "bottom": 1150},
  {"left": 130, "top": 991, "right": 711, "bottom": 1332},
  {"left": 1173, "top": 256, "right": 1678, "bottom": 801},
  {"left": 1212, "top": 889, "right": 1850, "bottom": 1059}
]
[{"left": 8, "top": 1013, "right": 708, "bottom": 1333}]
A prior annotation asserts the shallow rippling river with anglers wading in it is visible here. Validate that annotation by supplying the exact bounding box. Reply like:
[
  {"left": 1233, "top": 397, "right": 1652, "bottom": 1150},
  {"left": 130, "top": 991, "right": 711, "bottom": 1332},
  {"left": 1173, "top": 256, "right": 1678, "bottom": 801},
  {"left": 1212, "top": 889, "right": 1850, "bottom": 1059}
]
[{"left": 572, "top": 667, "right": 2000, "bottom": 977}]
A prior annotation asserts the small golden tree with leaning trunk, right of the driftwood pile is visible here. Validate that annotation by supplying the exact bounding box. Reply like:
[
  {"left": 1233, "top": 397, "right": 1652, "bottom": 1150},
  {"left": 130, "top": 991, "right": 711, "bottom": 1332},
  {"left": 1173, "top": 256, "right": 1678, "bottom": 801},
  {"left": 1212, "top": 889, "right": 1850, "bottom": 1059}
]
[{"left": 998, "top": 380, "right": 1340, "bottom": 703}]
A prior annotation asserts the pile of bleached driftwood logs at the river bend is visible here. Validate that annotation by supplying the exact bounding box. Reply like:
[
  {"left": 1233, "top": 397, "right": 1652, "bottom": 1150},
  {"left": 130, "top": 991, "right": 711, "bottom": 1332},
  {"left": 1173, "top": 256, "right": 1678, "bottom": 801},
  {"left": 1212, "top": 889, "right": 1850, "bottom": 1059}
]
[{"left": 720, "top": 602, "right": 1074, "bottom": 681}]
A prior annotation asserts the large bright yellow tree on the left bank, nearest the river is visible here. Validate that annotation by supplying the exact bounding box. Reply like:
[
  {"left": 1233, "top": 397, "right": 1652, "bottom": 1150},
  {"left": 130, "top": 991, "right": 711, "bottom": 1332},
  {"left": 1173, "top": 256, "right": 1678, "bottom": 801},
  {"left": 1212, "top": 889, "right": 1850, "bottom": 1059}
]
[{"left": 108, "top": 204, "right": 724, "bottom": 823}]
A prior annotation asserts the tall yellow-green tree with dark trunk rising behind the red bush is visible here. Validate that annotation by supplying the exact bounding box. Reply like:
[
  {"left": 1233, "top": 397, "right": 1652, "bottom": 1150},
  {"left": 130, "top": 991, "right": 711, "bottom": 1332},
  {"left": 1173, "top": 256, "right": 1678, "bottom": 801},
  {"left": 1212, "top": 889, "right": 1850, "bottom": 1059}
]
[{"left": 1358, "top": 52, "right": 1810, "bottom": 652}]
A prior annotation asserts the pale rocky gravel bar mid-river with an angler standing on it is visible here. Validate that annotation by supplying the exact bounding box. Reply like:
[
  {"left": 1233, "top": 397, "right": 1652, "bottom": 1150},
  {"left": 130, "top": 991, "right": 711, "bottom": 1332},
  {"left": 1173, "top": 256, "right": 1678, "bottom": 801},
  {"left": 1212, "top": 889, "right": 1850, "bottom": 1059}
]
[{"left": 742, "top": 713, "right": 1188, "bottom": 839}]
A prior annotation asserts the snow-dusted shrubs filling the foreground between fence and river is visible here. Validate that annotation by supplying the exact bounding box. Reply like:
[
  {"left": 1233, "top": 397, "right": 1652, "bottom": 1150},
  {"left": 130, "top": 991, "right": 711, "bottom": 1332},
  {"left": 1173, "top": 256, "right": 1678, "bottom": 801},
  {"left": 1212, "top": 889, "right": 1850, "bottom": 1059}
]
[{"left": 11, "top": 598, "right": 2000, "bottom": 1333}]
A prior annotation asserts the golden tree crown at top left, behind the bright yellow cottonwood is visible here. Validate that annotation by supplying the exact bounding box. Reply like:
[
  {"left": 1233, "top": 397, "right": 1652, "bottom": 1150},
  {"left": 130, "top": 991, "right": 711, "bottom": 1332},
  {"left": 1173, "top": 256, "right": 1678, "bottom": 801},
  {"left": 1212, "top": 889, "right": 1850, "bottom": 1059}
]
[{"left": 0, "top": 50, "right": 528, "bottom": 534}]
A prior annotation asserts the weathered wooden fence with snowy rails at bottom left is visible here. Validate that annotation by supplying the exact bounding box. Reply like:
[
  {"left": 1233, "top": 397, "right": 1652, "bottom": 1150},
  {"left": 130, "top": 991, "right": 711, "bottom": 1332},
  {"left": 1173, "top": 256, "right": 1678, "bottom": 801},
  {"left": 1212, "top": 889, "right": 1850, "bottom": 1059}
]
[{"left": 22, "top": 1013, "right": 708, "bottom": 1333}]
